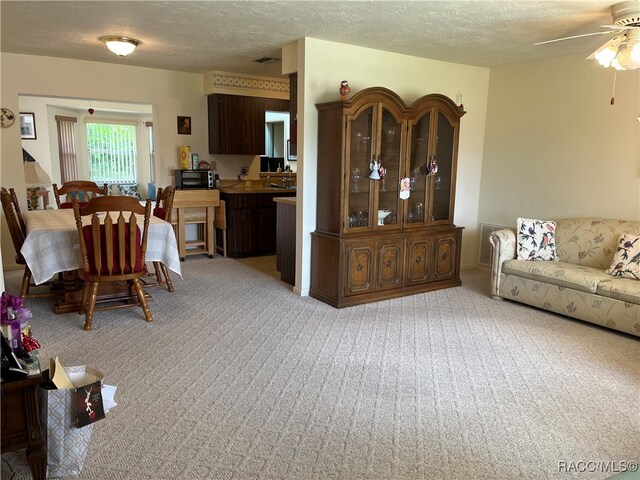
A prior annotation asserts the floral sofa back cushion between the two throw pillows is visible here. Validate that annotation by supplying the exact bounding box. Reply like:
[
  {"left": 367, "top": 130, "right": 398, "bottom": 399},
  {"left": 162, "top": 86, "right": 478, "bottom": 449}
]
[{"left": 556, "top": 217, "right": 640, "bottom": 270}]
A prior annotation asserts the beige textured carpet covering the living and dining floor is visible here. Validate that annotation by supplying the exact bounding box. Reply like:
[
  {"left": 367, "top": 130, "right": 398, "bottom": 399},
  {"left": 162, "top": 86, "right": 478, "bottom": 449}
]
[{"left": 2, "top": 256, "right": 640, "bottom": 480}]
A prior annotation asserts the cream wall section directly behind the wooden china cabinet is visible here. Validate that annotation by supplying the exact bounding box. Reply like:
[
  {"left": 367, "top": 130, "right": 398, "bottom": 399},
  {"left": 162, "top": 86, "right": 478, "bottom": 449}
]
[{"left": 296, "top": 38, "right": 489, "bottom": 295}]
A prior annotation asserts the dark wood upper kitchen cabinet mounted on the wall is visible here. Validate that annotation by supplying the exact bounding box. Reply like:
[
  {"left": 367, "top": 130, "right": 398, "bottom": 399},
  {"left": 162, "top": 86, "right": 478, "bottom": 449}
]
[{"left": 207, "top": 93, "right": 289, "bottom": 155}]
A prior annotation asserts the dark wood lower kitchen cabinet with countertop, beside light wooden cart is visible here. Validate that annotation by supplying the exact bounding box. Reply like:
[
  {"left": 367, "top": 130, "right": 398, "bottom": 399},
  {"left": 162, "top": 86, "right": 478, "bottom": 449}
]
[{"left": 217, "top": 191, "right": 296, "bottom": 258}]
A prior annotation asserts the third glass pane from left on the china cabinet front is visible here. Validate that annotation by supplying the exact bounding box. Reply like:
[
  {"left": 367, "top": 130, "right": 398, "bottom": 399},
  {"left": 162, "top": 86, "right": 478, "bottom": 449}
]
[{"left": 405, "top": 112, "right": 431, "bottom": 224}]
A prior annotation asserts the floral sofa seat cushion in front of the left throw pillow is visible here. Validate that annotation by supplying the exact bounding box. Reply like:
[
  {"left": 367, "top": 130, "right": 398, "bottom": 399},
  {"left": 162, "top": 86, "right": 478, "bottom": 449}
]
[{"left": 502, "top": 260, "right": 611, "bottom": 293}]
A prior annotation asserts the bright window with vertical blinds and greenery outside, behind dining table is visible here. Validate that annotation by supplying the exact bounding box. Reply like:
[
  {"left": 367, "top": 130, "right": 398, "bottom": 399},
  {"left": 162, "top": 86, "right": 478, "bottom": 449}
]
[{"left": 87, "top": 123, "right": 137, "bottom": 185}]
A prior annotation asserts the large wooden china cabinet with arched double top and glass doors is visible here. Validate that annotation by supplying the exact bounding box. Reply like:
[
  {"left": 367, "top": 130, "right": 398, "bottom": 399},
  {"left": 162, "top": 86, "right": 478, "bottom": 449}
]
[{"left": 310, "top": 87, "right": 465, "bottom": 308}]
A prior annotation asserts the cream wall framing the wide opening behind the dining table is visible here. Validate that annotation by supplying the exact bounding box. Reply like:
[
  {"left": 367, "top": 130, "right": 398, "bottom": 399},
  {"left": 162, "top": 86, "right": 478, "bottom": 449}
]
[{"left": 0, "top": 53, "right": 211, "bottom": 278}]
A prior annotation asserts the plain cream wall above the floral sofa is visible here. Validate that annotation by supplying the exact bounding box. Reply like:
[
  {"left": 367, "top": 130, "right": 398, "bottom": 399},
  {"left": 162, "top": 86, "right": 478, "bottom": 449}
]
[{"left": 479, "top": 56, "right": 640, "bottom": 225}]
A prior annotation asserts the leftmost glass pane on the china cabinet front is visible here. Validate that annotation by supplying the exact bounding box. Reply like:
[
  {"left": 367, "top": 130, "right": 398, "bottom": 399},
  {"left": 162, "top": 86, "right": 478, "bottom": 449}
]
[{"left": 346, "top": 106, "right": 375, "bottom": 229}]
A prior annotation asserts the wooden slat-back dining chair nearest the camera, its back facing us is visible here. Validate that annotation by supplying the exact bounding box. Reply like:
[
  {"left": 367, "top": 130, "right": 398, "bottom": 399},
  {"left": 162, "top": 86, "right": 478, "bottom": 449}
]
[{"left": 73, "top": 196, "right": 153, "bottom": 330}]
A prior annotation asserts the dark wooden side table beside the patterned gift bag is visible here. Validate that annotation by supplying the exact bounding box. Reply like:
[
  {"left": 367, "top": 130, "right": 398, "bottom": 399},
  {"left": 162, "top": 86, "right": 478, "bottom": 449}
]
[{"left": 2, "top": 375, "right": 47, "bottom": 480}]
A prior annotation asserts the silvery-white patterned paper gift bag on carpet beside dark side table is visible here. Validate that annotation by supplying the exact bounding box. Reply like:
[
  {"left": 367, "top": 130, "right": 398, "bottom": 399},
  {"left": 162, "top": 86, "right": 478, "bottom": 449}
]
[{"left": 38, "top": 366, "right": 103, "bottom": 478}]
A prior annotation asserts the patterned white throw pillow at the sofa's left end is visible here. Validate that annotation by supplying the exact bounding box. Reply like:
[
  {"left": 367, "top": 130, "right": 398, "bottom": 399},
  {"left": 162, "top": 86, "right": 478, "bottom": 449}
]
[{"left": 518, "top": 218, "right": 558, "bottom": 260}]
